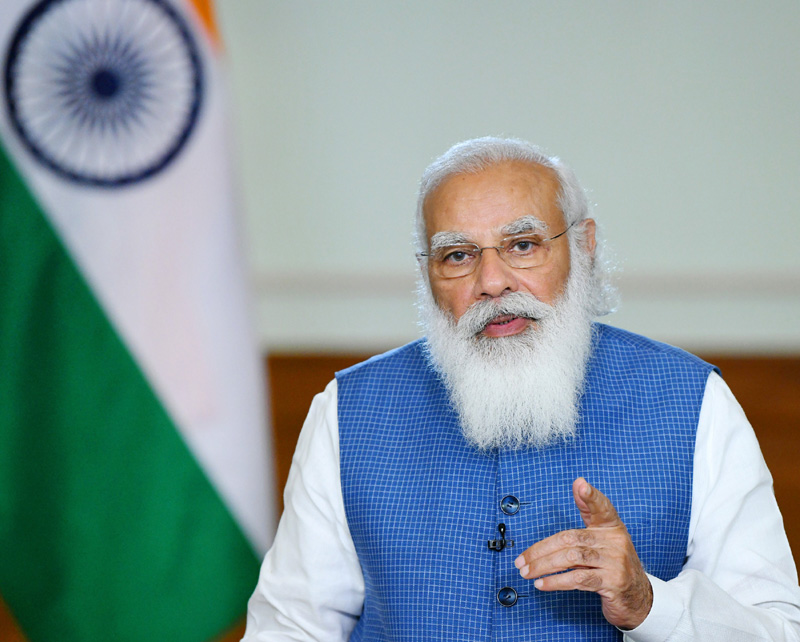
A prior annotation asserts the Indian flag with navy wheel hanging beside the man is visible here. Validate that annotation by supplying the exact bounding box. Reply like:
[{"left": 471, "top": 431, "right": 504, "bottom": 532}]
[{"left": 0, "top": 0, "right": 274, "bottom": 642}]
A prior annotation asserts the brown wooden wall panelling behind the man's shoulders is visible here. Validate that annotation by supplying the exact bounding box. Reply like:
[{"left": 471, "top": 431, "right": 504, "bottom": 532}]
[{"left": 267, "top": 354, "right": 800, "bottom": 561}]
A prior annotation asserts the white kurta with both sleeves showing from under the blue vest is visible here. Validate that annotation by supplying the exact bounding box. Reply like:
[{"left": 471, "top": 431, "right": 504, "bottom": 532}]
[{"left": 244, "top": 373, "right": 800, "bottom": 642}]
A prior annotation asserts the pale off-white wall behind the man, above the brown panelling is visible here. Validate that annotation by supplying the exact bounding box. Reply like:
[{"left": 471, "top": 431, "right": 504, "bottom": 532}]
[{"left": 217, "top": 0, "right": 800, "bottom": 353}]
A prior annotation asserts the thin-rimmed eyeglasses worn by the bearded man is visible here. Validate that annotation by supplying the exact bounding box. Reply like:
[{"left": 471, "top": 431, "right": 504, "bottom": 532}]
[{"left": 417, "top": 221, "right": 575, "bottom": 279}]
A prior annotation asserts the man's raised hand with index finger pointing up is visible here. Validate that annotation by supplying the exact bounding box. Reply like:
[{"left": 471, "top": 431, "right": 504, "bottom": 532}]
[{"left": 514, "top": 477, "right": 653, "bottom": 630}]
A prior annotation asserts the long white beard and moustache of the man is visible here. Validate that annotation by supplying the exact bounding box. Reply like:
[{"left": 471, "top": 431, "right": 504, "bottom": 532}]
[{"left": 418, "top": 250, "right": 592, "bottom": 450}]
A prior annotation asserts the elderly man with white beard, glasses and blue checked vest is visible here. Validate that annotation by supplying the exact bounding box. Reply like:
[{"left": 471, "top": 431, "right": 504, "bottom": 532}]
[{"left": 245, "top": 138, "right": 800, "bottom": 641}]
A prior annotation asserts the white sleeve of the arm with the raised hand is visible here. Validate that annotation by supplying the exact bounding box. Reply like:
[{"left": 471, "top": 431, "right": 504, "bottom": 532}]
[{"left": 624, "top": 373, "right": 800, "bottom": 642}]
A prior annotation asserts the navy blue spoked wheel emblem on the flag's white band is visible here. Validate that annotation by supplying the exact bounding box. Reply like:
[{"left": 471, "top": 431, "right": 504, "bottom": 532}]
[{"left": 4, "top": 0, "right": 203, "bottom": 187}]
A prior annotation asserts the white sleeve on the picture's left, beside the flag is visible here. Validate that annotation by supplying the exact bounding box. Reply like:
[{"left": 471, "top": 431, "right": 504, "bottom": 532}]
[{"left": 242, "top": 380, "right": 364, "bottom": 642}]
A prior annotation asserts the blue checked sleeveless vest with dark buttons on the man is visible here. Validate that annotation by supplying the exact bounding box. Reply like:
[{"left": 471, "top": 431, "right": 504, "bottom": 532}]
[{"left": 337, "top": 325, "right": 712, "bottom": 642}]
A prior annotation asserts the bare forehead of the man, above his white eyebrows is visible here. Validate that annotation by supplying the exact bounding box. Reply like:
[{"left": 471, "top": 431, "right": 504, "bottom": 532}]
[{"left": 423, "top": 161, "right": 563, "bottom": 240}]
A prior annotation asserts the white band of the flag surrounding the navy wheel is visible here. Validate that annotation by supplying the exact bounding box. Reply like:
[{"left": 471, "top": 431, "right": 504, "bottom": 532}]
[{"left": 0, "top": 0, "right": 274, "bottom": 553}]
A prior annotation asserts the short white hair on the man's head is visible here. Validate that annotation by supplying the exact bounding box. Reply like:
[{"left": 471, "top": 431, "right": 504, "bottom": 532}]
[{"left": 414, "top": 136, "right": 617, "bottom": 316}]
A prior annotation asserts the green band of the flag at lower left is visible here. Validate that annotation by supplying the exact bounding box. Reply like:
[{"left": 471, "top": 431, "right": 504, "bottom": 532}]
[{"left": 0, "top": 148, "right": 259, "bottom": 642}]
